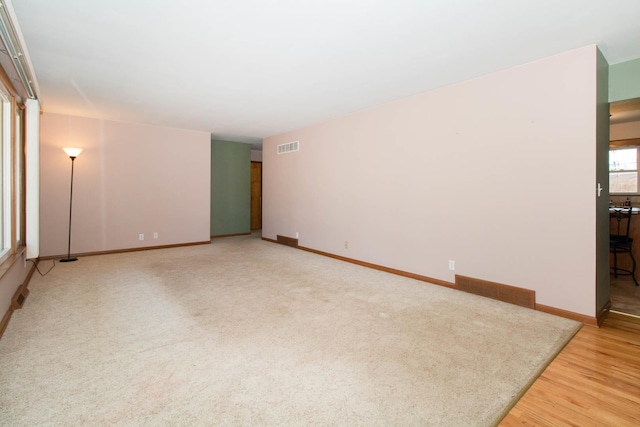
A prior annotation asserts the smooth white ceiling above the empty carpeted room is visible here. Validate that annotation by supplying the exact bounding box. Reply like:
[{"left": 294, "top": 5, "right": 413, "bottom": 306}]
[{"left": 7, "top": 0, "right": 640, "bottom": 149}]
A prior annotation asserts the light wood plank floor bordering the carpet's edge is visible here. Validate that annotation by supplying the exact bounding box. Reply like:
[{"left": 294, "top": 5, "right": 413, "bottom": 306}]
[{"left": 500, "top": 313, "right": 640, "bottom": 426}]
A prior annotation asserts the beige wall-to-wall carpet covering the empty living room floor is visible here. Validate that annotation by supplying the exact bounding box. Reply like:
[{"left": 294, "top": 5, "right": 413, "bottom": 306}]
[{"left": 0, "top": 236, "right": 579, "bottom": 426}]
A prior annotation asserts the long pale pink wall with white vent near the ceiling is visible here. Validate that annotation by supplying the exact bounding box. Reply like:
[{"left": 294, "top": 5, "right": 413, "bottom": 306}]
[{"left": 262, "top": 46, "right": 598, "bottom": 316}]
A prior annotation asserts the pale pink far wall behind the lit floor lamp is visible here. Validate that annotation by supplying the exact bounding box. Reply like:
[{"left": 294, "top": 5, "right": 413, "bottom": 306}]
[{"left": 40, "top": 113, "right": 211, "bottom": 256}]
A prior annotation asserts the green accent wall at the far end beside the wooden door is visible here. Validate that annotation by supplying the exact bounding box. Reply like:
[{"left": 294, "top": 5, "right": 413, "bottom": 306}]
[{"left": 211, "top": 140, "right": 251, "bottom": 236}]
